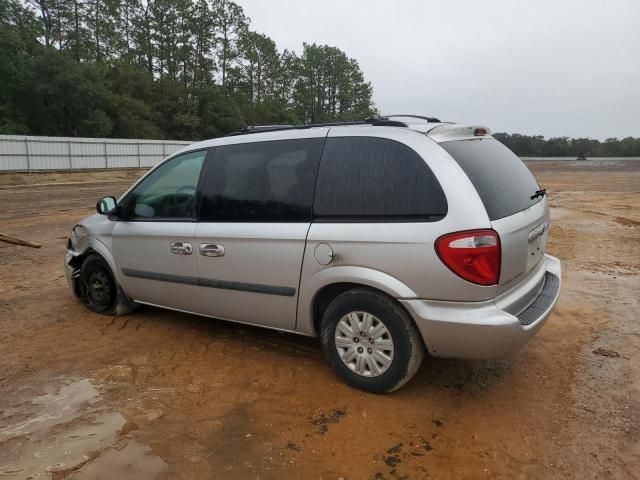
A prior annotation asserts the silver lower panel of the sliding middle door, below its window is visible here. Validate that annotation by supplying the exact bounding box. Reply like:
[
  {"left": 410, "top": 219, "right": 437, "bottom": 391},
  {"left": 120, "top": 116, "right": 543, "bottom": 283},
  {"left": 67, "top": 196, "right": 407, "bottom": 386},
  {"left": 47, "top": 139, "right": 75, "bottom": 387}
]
[{"left": 192, "top": 223, "right": 309, "bottom": 329}]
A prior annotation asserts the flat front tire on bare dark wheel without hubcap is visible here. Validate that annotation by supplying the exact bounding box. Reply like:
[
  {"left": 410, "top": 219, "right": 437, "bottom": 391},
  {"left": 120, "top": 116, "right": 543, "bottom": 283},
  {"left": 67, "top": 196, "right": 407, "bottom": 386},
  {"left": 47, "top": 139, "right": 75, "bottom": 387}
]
[{"left": 80, "top": 253, "right": 136, "bottom": 316}]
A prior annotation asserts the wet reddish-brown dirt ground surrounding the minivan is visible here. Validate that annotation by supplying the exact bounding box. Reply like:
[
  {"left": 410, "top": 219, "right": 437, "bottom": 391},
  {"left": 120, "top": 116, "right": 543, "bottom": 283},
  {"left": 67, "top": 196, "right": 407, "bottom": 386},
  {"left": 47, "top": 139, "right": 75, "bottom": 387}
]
[{"left": 0, "top": 162, "right": 640, "bottom": 480}]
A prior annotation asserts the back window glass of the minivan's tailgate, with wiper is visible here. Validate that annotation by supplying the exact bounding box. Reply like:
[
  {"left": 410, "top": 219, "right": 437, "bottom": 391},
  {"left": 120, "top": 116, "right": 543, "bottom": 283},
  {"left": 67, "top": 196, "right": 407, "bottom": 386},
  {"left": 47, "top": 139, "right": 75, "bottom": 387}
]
[{"left": 440, "top": 138, "right": 541, "bottom": 220}]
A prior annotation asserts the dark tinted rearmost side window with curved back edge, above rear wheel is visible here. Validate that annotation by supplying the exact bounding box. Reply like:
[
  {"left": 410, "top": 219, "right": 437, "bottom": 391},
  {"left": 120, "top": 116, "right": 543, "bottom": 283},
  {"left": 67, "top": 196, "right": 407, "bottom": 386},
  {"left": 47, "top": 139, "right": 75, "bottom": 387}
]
[{"left": 313, "top": 137, "right": 447, "bottom": 222}]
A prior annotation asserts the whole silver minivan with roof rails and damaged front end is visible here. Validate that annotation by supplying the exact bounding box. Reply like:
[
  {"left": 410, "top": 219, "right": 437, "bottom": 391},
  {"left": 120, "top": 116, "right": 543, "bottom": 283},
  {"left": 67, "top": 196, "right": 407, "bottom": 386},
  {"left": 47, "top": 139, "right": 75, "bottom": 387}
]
[{"left": 65, "top": 115, "right": 560, "bottom": 392}]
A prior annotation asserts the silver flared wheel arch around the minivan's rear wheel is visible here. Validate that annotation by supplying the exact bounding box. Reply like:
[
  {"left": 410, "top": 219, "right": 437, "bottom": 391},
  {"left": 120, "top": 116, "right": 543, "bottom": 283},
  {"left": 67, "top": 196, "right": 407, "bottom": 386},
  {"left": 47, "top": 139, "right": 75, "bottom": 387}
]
[{"left": 296, "top": 265, "right": 417, "bottom": 336}]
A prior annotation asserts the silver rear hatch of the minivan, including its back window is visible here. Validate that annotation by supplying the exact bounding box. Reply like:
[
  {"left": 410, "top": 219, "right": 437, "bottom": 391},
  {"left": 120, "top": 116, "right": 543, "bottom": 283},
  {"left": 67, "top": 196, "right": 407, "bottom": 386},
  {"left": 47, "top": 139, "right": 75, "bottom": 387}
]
[{"left": 440, "top": 136, "right": 549, "bottom": 294}]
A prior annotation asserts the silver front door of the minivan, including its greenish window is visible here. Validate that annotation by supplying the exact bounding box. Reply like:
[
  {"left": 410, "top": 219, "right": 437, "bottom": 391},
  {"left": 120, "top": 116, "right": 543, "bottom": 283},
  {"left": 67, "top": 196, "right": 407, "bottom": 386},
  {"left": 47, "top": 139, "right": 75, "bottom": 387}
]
[{"left": 112, "top": 150, "right": 207, "bottom": 311}]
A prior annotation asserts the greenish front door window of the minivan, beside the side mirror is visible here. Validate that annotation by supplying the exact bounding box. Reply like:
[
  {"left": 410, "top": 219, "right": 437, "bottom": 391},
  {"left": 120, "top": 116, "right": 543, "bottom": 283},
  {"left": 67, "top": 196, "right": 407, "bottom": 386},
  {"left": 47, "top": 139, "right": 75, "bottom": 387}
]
[{"left": 124, "top": 150, "right": 207, "bottom": 221}]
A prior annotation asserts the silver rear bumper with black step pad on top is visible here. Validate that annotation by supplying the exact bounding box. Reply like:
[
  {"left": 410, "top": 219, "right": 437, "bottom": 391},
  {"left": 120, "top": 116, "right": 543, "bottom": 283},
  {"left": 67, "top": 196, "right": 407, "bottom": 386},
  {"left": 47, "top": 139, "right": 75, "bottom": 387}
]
[{"left": 401, "top": 255, "right": 561, "bottom": 360}]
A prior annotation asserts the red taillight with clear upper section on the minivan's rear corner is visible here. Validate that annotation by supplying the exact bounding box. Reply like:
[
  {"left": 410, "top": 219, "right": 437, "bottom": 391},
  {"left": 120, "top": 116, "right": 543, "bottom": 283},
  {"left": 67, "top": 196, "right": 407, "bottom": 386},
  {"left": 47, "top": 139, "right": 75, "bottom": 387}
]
[{"left": 436, "top": 230, "right": 500, "bottom": 285}]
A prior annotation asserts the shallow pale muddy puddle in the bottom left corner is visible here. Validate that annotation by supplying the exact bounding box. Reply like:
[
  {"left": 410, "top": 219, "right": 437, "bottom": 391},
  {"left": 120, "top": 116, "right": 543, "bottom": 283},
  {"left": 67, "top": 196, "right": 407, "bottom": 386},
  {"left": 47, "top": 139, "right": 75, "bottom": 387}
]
[{"left": 0, "top": 379, "right": 167, "bottom": 480}]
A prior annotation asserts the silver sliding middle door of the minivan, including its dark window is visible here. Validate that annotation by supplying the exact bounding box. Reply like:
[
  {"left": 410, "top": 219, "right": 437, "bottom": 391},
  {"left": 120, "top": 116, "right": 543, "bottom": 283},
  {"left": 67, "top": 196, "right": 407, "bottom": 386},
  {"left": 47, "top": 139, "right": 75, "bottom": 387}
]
[{"left": 194, "top": 134, "right": 326, "bottom": 330}]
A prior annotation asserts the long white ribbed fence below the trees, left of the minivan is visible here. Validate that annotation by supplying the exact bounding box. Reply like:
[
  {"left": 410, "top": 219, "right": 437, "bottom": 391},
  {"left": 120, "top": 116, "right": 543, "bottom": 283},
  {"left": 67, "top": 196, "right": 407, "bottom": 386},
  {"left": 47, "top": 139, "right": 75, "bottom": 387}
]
[{"left": 0, "top": 135, "right": 191, "bottom": 172}]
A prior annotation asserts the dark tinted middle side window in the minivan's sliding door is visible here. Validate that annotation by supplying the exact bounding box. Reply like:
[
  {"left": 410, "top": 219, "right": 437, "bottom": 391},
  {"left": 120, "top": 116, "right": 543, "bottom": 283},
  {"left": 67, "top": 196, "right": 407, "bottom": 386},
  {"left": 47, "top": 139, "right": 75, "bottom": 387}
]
[{"left": 200, "top": 138, "right": 324, "bottom": 222}]
